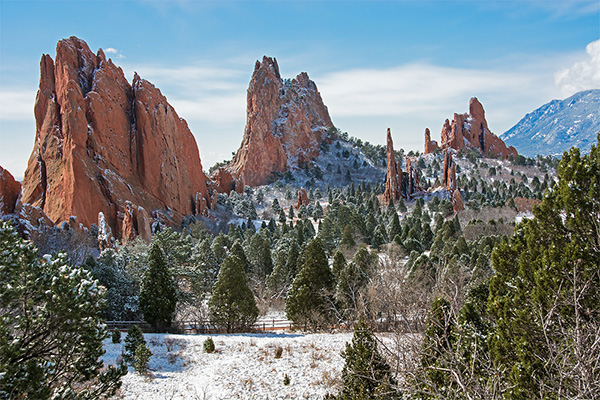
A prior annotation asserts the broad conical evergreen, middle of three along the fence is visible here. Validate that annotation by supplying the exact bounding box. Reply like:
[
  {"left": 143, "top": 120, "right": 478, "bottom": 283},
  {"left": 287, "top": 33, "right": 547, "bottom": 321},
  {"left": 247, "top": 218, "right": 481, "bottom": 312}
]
[{"left": 208, "top": 255, "right": 258, "bottom": 333}]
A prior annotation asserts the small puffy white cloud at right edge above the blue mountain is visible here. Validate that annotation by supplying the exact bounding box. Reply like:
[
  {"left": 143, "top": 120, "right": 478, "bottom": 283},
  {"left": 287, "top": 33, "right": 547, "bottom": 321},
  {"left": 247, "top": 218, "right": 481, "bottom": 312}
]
[{"left": 554, "top": 39, "right": 600, "bottom": 97}]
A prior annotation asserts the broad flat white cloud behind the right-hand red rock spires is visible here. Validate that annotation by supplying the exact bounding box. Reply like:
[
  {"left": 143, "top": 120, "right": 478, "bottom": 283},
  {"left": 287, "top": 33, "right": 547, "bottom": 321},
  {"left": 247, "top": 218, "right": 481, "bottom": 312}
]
[{"left": 315, "top": 57, "right": 557, "bottom": 149}]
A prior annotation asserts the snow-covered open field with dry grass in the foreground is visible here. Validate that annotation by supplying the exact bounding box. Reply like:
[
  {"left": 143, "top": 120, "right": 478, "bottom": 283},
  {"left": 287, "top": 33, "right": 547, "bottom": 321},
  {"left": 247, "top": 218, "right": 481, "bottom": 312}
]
[{"left": 104, "top": 333, "right": 352, "bottom": 400}]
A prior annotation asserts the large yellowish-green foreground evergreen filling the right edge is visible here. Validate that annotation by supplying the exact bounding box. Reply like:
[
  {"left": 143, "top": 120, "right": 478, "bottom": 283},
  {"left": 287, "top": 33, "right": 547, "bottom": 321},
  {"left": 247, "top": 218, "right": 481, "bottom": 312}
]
[{"left": 488, "top": 135, "right": 600, "bottom": 399}]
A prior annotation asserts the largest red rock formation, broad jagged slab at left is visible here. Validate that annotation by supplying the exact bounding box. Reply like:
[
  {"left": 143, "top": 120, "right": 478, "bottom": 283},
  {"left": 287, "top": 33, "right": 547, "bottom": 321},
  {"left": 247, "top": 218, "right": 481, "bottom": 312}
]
[{"left": 22, "top": 37, "right": 210, "bottom": 237}]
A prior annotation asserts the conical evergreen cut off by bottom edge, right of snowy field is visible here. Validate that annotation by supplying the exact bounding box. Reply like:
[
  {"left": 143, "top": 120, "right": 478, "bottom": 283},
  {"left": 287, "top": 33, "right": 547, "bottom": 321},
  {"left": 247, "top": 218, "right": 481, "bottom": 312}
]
[{"left": 336, "top": 320, "right": 402, "bottom": 400}]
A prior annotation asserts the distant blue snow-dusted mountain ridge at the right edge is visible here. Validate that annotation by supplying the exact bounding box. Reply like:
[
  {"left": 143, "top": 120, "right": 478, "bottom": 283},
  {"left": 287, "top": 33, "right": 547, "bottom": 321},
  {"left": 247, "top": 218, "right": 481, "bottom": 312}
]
[{"left": 500, "top": 89, "right": 600, "bottom": 157}]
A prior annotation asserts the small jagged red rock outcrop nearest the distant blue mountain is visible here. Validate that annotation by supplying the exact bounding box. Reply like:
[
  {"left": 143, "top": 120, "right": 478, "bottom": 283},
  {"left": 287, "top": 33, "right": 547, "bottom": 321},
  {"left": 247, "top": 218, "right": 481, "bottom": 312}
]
[{"left": 425, "top": 97, "right": 517, "bottom": 158}]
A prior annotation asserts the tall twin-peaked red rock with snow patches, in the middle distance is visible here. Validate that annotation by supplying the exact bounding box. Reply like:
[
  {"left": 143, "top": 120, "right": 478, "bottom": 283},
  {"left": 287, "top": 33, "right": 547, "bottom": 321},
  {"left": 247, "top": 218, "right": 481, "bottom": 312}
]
[{"left": 217, "top": 56, "right": 333, "bottom": 191}]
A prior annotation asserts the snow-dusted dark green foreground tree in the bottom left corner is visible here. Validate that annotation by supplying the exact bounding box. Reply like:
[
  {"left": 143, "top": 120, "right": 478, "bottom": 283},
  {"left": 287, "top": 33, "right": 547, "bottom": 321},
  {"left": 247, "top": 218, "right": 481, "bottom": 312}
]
[{"left": 0, "top": 222, "right": 127, "bottom": 399}]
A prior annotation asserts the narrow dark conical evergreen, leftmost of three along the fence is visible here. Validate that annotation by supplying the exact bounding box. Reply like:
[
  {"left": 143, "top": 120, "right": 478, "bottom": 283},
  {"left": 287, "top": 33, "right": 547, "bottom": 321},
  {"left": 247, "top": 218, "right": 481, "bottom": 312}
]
[{"left": 140, "top": 243, "right": 177, "bottom": 331}]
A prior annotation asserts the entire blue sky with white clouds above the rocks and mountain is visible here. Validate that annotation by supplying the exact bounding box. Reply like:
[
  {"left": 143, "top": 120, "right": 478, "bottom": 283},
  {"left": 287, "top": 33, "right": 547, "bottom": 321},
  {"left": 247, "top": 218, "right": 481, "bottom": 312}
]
[{"left": 0, "top": 0, "right": 600, "bottom": 179}]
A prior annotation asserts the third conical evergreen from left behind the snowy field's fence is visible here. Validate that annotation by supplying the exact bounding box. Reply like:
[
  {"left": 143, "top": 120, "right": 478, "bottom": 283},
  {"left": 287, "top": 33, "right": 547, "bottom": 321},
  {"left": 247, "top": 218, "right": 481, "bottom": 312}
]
[{"left": 285, "top": 238, "right": 334, "bottom": 329}]
